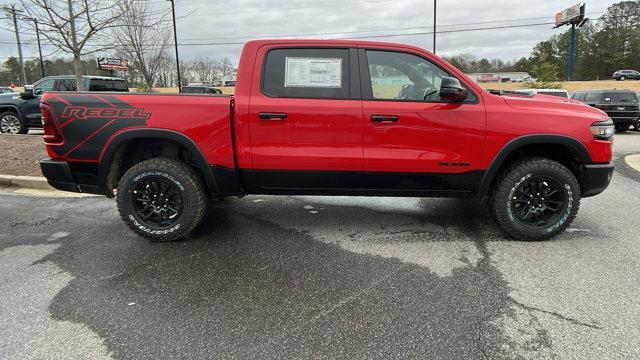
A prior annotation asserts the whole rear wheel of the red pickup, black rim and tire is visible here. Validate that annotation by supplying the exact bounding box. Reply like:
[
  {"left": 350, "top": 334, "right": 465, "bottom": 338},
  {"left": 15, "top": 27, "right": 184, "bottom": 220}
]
[{"left": 116, "top": 158, "right": 206, "bottom": 241}]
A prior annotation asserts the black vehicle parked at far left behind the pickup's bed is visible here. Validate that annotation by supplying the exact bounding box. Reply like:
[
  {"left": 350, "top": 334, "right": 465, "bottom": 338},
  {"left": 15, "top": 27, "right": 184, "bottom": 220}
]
[{"left": 0, "top": 75, "right": 129, "bottom": 134}]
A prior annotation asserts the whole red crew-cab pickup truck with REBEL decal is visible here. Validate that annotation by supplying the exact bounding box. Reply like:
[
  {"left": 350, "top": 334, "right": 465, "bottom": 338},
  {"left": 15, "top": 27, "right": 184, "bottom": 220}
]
[{"left": 41, "top": 40, "right": 614, "bottom": 241}]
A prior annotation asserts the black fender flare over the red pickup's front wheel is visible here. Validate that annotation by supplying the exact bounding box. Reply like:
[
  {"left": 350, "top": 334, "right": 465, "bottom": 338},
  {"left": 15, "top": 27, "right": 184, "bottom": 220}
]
[{"left": 478, "top": 134, "right": 592, "bottom": 197}]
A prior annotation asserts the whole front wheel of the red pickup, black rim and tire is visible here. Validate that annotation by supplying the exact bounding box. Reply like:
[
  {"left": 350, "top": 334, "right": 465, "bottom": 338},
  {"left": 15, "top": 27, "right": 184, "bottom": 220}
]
[{"left": 490, "top": 158, "right": 580, "bottom": 241}]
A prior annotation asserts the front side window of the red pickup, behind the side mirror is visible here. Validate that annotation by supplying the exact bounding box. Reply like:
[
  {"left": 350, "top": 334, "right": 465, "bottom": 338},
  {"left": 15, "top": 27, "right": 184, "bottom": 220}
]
[{"left": 367, "top": 50, "right": 449, "bottom": 102}]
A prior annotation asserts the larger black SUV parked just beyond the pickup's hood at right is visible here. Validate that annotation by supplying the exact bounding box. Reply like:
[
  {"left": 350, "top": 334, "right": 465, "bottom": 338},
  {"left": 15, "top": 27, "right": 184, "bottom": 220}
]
[{"left": 571, "top": 90, "right": 640, "bottom": 132}]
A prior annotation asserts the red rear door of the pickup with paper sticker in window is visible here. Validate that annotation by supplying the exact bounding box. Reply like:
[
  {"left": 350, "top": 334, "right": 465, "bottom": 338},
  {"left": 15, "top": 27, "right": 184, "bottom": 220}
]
[{"left": 244, "top": 47, "right": 362, "bottom": 193}]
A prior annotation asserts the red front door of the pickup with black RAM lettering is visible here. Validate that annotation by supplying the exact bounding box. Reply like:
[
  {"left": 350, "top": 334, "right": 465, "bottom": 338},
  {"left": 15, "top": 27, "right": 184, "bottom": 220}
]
[{"left": 360, "top": 49, "right": 486, "bottom": 193}]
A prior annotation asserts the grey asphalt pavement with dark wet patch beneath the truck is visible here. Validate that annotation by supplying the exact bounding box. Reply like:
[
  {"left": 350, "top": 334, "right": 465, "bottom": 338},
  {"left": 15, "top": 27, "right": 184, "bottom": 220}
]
[{"left": 0, "top": 132, "right": 640, "bottom": 359}]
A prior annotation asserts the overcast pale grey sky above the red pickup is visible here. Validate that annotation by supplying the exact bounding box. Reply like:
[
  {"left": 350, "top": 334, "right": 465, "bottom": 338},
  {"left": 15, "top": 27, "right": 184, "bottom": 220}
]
[{"left": 0, "top": 0, "right": 617, "bottom": 63}]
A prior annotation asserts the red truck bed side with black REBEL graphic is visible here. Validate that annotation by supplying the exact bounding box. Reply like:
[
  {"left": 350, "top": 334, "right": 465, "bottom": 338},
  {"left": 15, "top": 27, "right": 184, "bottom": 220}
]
[{"left": 42, "top": 92, "right": 234, "bottom": 168}]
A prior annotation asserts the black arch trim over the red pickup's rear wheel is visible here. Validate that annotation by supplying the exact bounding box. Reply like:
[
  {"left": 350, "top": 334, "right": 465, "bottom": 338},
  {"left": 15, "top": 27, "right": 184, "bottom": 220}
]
[{"left": 97, "top": 128, "right": 218, "bottom": 197}]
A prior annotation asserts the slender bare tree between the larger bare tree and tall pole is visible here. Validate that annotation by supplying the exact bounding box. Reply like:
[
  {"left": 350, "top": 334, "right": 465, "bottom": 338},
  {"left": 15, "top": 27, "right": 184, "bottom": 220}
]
[{"left": 113, "top": 1, "right": 171, "bottom": 90}]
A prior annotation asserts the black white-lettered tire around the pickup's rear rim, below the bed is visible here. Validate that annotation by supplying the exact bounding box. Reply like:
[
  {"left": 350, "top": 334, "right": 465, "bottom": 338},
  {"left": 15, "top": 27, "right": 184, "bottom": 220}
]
[{"left": 116, "top": 158, "right": 206, "bottom": 242}]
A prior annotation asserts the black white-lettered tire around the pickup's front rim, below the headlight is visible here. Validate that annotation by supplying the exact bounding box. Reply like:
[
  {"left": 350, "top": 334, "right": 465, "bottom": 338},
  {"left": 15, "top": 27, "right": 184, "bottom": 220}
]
[{"left": 489, "top": 157, "right": 581, "bottom": 241}]
